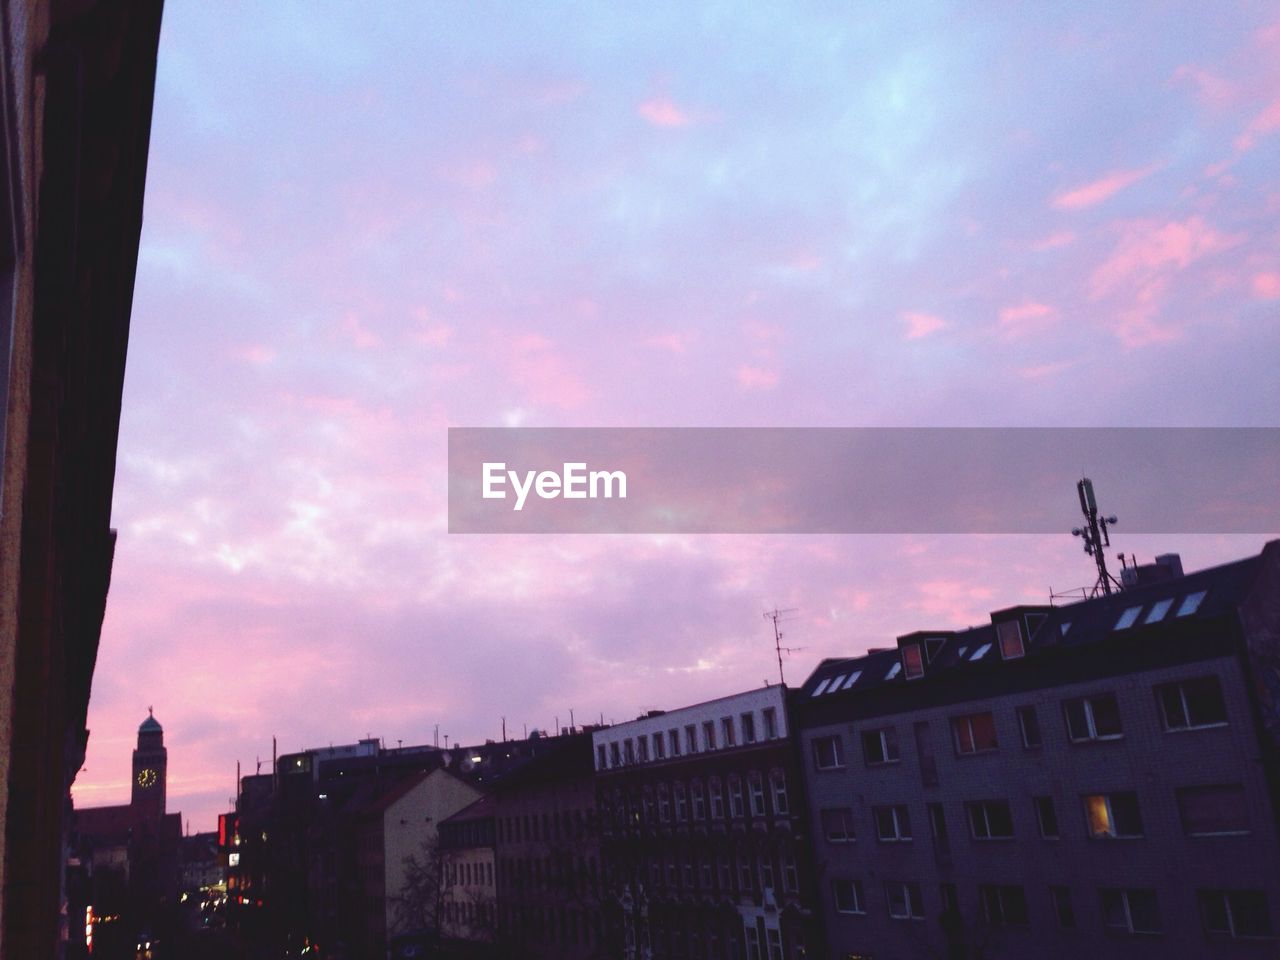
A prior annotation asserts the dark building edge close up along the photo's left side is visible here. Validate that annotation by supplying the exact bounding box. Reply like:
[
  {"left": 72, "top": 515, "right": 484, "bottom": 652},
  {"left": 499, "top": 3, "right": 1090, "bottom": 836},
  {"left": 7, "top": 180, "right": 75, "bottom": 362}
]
[{"left": 0, "top": 0, "right": 161, "bottom": 957}]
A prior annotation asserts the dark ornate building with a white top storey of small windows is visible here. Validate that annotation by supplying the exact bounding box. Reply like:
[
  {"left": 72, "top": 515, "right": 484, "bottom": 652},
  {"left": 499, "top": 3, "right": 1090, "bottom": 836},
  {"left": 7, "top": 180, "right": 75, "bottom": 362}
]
[{"left": 594, "top": 686, "right": 820, "bottom": 960}]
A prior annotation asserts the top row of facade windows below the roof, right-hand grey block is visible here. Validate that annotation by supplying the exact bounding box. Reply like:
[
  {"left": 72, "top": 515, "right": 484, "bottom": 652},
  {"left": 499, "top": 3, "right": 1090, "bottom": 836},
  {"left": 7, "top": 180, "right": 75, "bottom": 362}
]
[{"left": 813, "top": 676, "right": 1228, "bottom": 771}]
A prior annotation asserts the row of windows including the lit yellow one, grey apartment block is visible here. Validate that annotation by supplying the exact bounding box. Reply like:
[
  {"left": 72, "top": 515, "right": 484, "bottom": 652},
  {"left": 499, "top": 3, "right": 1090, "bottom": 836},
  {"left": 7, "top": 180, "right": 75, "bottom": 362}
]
[{"left": 819, "top": 783, "right": 1251, "bottom": 844}]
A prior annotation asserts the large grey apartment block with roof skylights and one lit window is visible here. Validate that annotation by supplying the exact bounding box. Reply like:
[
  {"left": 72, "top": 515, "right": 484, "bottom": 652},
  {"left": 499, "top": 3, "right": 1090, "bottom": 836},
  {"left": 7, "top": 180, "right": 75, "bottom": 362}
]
[{"left": 792, "top": 541, "right": 1280, "bottom": 960}]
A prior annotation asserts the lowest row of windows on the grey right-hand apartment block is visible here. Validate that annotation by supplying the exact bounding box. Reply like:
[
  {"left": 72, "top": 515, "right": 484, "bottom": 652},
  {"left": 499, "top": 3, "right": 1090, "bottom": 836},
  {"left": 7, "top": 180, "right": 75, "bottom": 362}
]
[{"left": 832, "top": 877, "right": 1272, "bottom": 938}]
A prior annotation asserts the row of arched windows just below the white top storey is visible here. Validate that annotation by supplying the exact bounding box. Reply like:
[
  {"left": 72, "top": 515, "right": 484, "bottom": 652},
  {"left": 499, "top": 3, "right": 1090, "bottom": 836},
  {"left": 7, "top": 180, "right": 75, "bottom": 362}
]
[{"left": 614, "top": 769, "right": 791, "bottom": 827}]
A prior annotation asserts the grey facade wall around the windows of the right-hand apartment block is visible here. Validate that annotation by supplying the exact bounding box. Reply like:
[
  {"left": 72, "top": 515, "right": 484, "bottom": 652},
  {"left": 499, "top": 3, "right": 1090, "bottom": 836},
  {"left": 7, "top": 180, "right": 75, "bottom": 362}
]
[{"left": 801, "top": 649, "right": 1280, "bottom": 960}]
